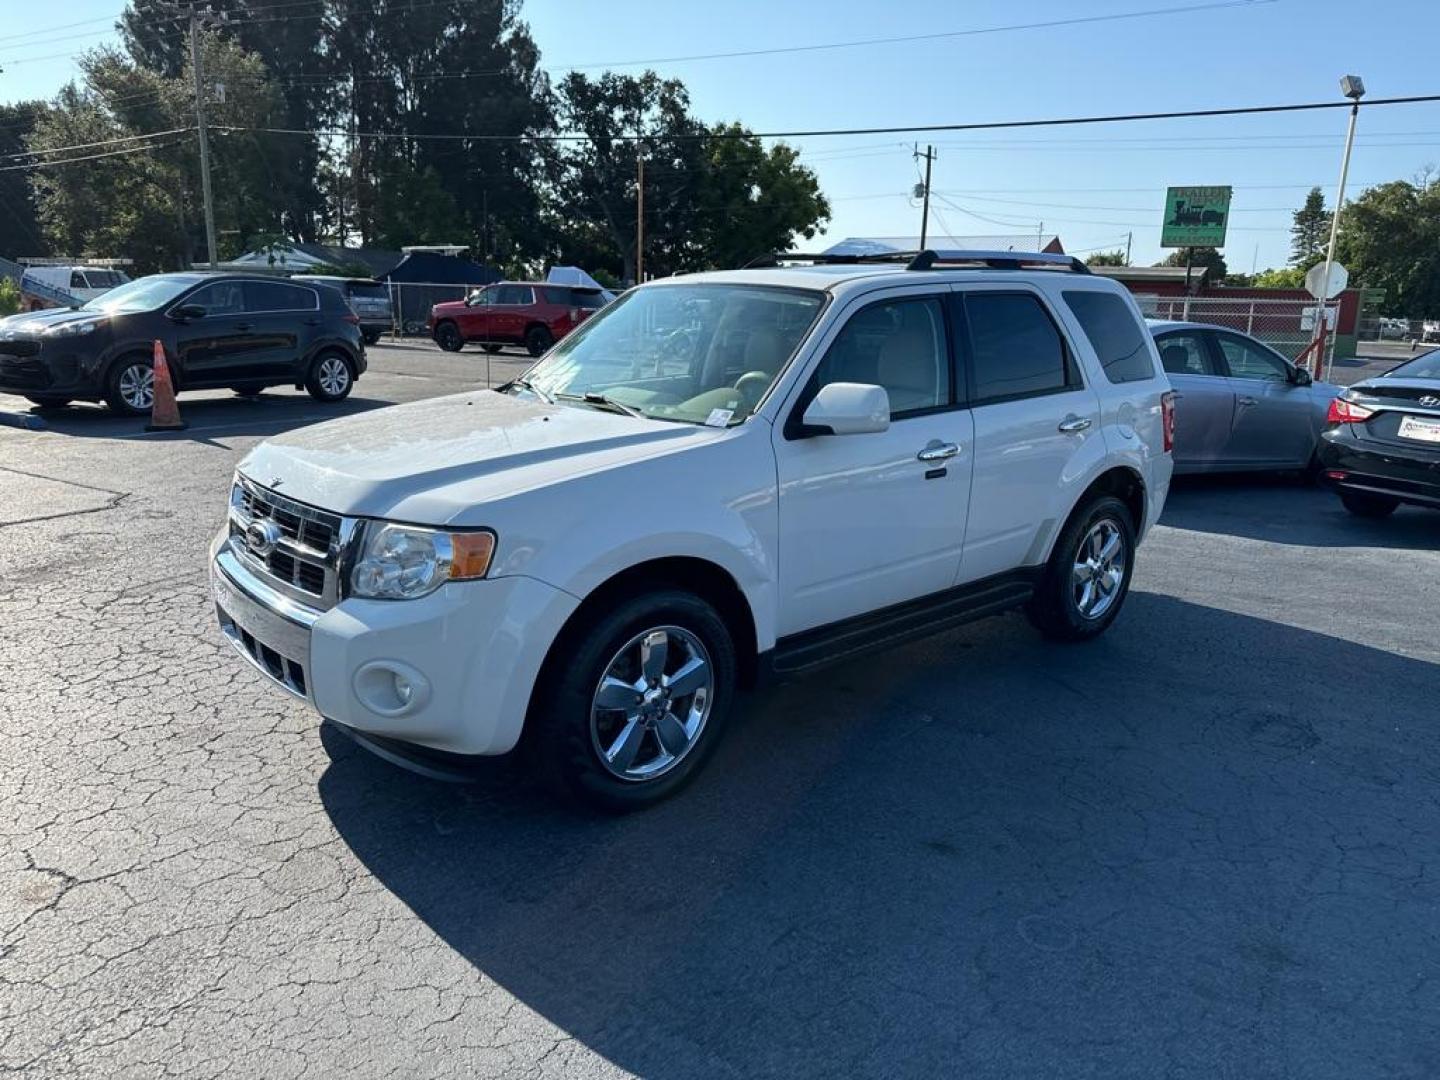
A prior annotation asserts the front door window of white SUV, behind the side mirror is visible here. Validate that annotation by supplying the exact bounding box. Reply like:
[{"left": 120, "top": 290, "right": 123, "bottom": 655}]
[{"left": 802, "top": 298, "right": 953, "bottom": 419}]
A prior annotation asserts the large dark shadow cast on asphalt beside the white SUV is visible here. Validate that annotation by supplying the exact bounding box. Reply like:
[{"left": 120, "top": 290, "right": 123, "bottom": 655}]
[{"left": 320, "top": 593, "right": 1440, "bottom": 1077}]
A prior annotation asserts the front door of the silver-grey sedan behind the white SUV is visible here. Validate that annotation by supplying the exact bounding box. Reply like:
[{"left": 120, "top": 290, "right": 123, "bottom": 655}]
[{"left": 1212, "top": 330, "right": 1319, "bottom": 468}]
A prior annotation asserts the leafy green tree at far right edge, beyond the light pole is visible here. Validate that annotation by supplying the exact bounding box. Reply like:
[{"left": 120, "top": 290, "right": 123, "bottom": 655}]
[{"left": 1338, "top": 176, "right": 1440, "bottom": 318}]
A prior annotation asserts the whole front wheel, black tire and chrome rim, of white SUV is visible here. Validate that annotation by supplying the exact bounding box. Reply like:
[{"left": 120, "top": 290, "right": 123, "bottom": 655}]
[{"left": 526, "top": 589, "right": 736, "bottom": 811}]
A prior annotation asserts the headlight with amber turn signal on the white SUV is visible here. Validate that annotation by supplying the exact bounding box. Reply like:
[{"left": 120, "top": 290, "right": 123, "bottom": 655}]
[{"left": 350, "top": 523, "right": 495, "bottom": 600}]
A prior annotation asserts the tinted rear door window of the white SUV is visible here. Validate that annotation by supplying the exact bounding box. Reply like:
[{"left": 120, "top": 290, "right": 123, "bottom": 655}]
[{"left": 965, "top": 292, "right": 1077, "bottom": 405}]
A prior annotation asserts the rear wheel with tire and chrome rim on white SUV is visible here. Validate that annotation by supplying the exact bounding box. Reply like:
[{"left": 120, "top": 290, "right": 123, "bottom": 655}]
[{"left": 1025, "top": 495, "right": 1135, "bottom": 641}]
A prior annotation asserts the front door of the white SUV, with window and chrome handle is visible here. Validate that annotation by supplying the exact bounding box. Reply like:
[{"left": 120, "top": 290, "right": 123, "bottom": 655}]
[{"left": 773, "top": 289, "right": 971, "bottom": 636}]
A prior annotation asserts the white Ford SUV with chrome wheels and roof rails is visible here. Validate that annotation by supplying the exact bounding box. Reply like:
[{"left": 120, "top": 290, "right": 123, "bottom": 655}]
[{"left": 212, "top": 252, "right": 1172, "bottom": 809}]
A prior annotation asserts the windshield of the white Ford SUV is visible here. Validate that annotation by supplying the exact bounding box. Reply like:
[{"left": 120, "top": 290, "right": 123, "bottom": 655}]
[{"left": 517, "top": 284, "right": 825, "bottom": 426}]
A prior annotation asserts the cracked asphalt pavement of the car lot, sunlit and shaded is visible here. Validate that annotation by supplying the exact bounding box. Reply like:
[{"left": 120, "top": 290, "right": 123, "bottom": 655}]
[{"left": 0, "top": 347, "right": 1440, "bottom": 1079}]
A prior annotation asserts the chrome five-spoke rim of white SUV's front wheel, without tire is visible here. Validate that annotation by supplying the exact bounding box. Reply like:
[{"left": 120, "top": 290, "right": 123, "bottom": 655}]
[{"left": 590, "top": 626, "right": 714, "bottom": 780}]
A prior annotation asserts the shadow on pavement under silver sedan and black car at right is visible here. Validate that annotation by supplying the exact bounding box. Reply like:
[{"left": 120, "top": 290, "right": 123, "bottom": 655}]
[{"left": 1161, "top": 472, "right": 1440, "bottom": 550}]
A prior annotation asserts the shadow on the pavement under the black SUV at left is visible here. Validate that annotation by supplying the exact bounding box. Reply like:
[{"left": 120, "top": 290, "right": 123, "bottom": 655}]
[{"left": 8, "top": 390, "right": 392, "bottom": 442}]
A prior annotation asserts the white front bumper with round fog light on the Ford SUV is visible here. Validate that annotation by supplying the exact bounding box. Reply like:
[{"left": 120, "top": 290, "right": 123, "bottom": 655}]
[{"left": 210, "top": 537, "right": 577, "bottom": 755}]
